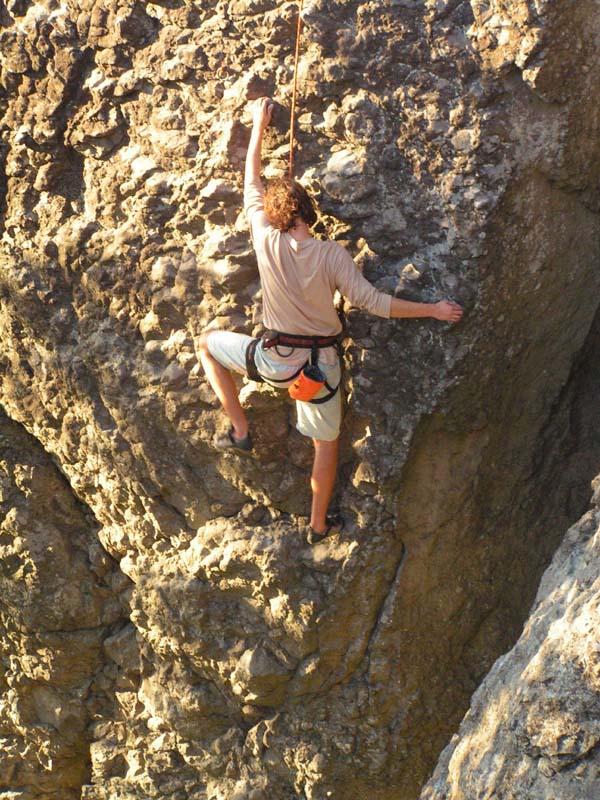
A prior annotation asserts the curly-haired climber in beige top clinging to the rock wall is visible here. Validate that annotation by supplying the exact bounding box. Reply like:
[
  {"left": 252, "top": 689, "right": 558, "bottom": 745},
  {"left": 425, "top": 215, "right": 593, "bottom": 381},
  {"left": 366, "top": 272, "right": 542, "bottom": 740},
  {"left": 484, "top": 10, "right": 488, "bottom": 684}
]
[{"left": 198, "top": 97, "right": 463, "bottom": 544}]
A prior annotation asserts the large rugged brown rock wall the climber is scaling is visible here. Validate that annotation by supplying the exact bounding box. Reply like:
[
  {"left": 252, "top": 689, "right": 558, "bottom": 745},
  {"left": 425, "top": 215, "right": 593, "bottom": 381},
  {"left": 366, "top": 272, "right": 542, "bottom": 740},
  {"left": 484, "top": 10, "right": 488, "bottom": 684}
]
[{"left": 0, "top": 0, "right": 600, "bottom": 800}]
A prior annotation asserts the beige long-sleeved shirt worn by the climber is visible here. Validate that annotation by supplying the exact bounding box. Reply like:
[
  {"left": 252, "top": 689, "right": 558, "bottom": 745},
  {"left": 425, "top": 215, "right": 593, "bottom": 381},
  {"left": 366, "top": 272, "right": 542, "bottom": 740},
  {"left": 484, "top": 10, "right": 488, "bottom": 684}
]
[{"left": 244, "top": 179, "right": 392, "bottom": 336}]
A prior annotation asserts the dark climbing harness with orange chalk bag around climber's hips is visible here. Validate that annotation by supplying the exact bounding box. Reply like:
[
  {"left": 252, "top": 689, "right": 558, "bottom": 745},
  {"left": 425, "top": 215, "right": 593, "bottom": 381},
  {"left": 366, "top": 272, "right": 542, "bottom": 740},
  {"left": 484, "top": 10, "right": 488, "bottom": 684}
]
[{"left": 246, "top": 331, "right": 341, "bottom": 404}]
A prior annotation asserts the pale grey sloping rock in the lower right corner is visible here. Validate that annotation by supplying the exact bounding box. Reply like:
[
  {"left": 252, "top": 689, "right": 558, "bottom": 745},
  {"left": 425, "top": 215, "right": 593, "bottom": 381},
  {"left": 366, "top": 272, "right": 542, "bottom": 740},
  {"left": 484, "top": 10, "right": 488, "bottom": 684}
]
[{"left": 421, "top": 478, "right": 600, "bottom": 800}]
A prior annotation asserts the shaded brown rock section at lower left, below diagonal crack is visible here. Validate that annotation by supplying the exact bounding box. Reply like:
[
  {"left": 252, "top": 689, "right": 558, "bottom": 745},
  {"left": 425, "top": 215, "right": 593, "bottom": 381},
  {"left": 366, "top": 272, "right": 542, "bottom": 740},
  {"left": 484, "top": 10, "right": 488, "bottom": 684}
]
[{"left": 0, "top": 414, "right": 125, "bottom": 800}]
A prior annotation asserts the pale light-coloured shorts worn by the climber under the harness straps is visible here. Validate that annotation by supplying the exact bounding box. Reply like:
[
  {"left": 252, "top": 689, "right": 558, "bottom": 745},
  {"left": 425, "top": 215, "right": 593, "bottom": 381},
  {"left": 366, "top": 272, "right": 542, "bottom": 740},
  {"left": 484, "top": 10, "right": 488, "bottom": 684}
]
[{"left": 206, "top": 330, "right": 342, "bottom": 442}]
